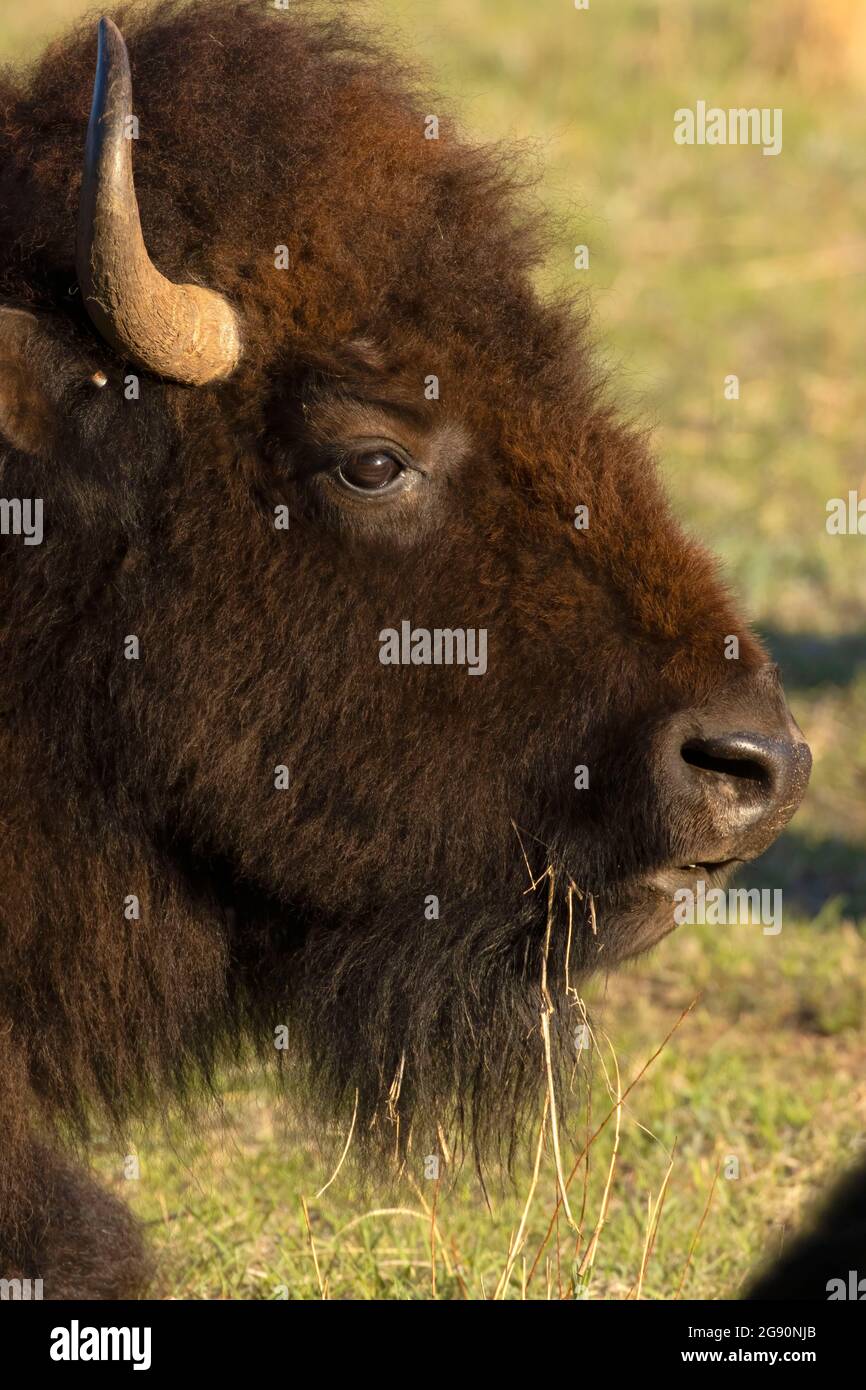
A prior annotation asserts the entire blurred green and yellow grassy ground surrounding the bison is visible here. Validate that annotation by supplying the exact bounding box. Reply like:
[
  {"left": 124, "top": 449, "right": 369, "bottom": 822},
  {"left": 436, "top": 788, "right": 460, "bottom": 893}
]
[{"left": 6, "top": 0, "right": 866, "bottom": 1298}]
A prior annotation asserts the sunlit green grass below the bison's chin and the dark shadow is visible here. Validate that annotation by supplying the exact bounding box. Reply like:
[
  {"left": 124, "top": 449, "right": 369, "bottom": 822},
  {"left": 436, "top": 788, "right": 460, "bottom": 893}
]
[{"left": 86, "top": 922, "right": 866, "bottom": 1298}]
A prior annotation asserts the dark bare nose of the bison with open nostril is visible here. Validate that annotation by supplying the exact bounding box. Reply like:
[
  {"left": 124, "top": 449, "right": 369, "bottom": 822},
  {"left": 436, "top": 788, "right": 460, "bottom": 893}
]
[{"left": 663, "top": 706, "right": 812, "bottom": 865}]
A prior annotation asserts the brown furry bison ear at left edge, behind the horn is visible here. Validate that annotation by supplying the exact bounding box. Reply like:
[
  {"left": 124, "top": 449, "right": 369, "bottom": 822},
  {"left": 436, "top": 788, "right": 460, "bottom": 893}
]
[{"left": 0, "top": 309, "right": 57, "bottom": 456}]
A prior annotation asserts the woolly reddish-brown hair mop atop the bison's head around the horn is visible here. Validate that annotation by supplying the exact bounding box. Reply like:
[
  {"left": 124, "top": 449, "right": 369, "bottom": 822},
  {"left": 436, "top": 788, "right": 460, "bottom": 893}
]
[{"left": 0, "top": 0, "right": 583, "bottom": 397}]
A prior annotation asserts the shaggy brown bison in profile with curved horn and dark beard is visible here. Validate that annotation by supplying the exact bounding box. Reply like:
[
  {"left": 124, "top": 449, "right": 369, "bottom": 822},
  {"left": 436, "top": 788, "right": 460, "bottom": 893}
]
[{"left": 0, "top": 0, "right": 809, "bottom": 1298}]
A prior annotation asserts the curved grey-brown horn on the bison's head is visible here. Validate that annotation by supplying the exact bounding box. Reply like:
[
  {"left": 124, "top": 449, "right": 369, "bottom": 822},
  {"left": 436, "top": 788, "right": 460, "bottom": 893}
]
[{"left": 76, "top": 19, "right": 240, "bottom": 386}]
